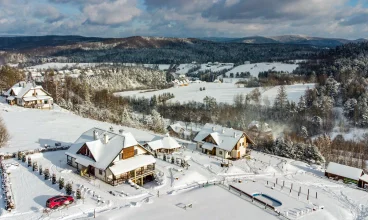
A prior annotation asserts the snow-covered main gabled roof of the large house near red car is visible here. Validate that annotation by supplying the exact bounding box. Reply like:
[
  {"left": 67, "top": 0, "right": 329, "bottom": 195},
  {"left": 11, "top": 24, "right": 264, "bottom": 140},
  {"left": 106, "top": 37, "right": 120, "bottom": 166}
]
[{"left": 65, "top": 128, "right": 139, "bottom": 169}]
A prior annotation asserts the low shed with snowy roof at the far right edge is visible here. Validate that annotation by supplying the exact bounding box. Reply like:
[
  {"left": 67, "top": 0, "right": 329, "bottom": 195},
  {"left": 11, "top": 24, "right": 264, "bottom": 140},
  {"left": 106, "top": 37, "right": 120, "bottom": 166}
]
[{"left": 325, "top": 162, "right": 364, "bottom": 185}]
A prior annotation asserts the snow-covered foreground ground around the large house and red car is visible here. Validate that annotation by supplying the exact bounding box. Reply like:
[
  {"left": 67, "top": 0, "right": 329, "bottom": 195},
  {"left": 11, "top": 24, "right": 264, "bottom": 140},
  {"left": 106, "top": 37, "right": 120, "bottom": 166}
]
[{"left": 0, "top": 103, "right": 368, "bottom": 220}]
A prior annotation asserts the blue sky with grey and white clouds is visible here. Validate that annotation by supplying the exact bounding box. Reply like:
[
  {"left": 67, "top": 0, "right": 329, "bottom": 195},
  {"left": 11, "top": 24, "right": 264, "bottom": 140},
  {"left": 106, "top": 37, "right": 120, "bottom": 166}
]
[{"left": 0, "top": 0, "right": 368, "bottom": 39}]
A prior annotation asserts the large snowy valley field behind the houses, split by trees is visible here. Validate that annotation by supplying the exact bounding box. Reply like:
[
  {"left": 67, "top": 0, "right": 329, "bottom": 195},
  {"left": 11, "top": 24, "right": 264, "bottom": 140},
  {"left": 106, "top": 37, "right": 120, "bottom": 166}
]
[{"left": 116, "top": 83, "right": 314, "bottom": 104}]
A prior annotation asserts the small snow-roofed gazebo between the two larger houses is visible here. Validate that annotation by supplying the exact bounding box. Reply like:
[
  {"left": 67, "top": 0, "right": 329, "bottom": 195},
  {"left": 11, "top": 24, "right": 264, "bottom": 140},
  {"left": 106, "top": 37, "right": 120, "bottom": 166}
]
[{"left": 144, "top": 134, "right": 181, "bottom": 154}]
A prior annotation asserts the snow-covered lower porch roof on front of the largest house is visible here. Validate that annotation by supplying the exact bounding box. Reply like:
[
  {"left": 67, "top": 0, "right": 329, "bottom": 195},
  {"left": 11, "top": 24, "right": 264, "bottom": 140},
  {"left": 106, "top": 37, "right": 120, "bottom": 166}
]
[{"left": 109, "top": 155, "right": 156, "bottom": 176}]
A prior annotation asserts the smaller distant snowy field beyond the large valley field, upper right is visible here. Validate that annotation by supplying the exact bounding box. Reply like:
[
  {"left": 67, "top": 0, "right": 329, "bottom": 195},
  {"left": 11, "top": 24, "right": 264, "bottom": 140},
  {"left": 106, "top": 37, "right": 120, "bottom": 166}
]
[{"left": 226, "top": 63, "right": 299, "bottom": 77}]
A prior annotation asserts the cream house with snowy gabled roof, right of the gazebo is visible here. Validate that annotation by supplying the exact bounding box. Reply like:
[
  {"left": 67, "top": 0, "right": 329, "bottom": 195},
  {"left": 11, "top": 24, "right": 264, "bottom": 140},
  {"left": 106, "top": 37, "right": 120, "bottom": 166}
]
[{"left": 194, "top": 123, "right": 254, "bottom": 159}]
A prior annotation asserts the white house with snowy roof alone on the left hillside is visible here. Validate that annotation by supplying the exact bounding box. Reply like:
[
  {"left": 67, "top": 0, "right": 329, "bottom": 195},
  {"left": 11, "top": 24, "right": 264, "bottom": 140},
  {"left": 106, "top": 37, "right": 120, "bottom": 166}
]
[{"left": 4, "top": 81, "right": 53, "bottom": 109}]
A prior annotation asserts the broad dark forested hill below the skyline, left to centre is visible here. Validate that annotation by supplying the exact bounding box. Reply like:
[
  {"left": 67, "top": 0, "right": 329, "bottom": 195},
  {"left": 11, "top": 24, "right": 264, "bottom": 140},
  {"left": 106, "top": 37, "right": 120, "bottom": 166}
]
[{"left": 0, "top": 36, "right": 322, "bottom": 64}]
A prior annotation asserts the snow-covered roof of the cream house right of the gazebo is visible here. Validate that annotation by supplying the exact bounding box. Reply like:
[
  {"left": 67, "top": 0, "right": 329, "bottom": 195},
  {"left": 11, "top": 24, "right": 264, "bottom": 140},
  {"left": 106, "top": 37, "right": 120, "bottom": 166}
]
[{"left": 194, "top": 123, "right": 250, "bottom": 151}]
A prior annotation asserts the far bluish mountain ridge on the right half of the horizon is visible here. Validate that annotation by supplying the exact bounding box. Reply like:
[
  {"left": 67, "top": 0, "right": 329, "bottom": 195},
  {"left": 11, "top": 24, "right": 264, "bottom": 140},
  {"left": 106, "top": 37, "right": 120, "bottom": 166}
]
[{"left": 204, "top": 35, "right": 368, "bottom": 47}]
